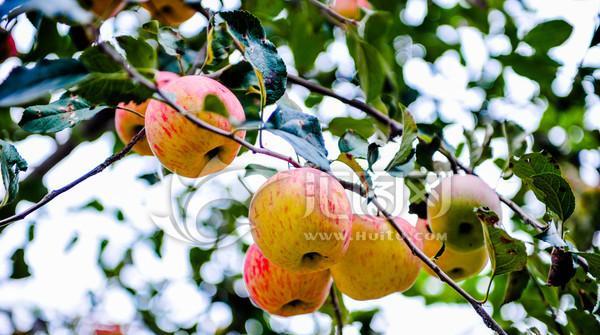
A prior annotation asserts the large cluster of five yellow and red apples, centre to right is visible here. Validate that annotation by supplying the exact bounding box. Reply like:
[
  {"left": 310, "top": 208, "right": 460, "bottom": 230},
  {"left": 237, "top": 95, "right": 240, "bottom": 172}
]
[{"left": 244, "top": 168, "right": 500, "bottom": 316}]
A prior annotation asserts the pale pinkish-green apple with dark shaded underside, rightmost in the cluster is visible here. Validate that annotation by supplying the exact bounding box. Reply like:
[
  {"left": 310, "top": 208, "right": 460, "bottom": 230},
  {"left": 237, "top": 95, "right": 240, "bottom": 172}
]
[{"left": 427, "top": 175, "right": 502, "bottom": 252}]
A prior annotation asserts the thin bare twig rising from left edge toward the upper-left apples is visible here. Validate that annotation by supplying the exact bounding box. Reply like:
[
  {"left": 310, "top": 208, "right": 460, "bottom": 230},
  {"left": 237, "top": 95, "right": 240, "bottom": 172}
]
[{"left": 0, "top": 129, "right": 146, "bottom": 227}]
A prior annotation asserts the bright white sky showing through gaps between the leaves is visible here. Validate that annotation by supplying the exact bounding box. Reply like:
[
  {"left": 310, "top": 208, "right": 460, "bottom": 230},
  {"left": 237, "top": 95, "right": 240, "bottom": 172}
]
[{"left": 0, "top": 0, "right": 600, "bottom": 335}]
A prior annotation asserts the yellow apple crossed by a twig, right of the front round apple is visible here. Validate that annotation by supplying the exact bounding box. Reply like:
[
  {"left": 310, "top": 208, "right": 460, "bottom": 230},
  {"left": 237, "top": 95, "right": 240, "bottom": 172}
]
[{"left": 331, "top": 215, "right": 422, "bottom": 300}]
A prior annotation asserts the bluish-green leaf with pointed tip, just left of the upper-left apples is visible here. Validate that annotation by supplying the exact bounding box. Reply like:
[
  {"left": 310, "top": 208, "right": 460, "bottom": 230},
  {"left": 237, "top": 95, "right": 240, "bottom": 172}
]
[{"left": 19, "top": 97, "right": 108, "bottom": 134}]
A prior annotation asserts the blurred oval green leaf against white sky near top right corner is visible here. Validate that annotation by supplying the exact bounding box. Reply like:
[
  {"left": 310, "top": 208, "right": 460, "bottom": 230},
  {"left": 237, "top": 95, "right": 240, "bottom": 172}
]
[{"left": 523, "top": 20, "right": 573, "bottom": 53}]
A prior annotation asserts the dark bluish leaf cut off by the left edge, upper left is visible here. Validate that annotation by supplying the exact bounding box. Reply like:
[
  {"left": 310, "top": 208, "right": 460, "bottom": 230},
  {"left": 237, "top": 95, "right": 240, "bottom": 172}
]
[{"left": 0, "top": 59, "right": 88, "bottom": 107}]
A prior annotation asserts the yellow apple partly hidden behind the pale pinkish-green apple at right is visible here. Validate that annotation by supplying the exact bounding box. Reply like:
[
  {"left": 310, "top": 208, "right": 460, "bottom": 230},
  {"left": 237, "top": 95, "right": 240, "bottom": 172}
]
[{"left": 417, "top": 219, "right": 489, "bottom": 281}]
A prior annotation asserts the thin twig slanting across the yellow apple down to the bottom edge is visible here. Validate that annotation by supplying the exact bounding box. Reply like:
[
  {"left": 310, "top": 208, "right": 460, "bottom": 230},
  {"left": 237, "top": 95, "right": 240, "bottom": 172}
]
[{"left": 372, "top": 197, "right": 507, "bottom": 335}]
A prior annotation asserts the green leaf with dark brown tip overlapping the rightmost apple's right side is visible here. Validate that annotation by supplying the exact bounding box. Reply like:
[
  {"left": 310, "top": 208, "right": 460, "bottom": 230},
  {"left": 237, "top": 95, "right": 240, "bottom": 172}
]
[{"left": 477, "top": 208, "right": 527, "bottom": 277}]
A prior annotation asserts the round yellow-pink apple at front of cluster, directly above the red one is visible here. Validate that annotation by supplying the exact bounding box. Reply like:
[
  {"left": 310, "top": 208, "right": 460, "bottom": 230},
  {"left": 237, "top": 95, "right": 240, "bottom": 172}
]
[{"left": 248, "top": 168, "right": 352, "bottom": 272}]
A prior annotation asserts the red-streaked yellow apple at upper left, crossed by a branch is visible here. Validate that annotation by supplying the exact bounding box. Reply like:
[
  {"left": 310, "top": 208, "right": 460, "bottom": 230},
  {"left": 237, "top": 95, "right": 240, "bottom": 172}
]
[{"left": 145, "top": 76, "right": 246, "bottom": 178}]
